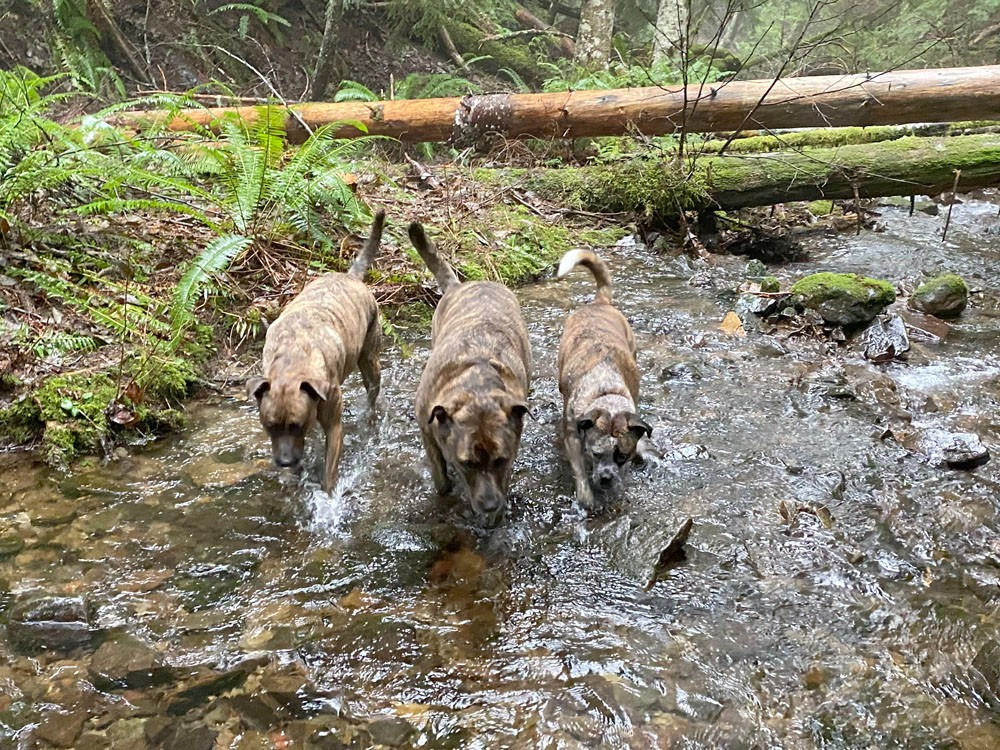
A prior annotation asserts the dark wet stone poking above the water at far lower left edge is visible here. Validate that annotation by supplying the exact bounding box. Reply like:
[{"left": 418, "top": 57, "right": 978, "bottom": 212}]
[{"left": 7, "top": 596, "right": 93, "bottom": 650}]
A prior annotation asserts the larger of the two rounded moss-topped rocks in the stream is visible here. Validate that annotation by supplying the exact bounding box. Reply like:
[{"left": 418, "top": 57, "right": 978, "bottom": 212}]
[{"left": 789, "top": 271, "right": 896, "bottom": 327}]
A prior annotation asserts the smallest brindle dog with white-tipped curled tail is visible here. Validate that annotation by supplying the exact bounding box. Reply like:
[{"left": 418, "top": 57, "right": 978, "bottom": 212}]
[{"left": 557, "top": 250, "right": 652, "bottom": 511}]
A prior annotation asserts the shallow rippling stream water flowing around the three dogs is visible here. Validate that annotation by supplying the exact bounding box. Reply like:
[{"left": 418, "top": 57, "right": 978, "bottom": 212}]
[{"left": 0, "top": 200, "right": 1000, "bottom": 750}]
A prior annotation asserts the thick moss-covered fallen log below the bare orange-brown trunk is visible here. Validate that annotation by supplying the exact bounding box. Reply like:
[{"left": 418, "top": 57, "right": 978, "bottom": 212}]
[{"left": 500, "top": 134, "right": 1000, "bottom": 217}]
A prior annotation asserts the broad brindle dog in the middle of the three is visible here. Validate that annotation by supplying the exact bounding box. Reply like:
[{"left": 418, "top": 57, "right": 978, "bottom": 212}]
[{"left": 410, "top": 224, "right": 531, "bottom": 525}]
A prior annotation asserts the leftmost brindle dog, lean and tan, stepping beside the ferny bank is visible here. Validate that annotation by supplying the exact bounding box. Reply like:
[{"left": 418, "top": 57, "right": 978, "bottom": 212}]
[{"left": 247, "top": 211, "right": 385, "bottom": 491}]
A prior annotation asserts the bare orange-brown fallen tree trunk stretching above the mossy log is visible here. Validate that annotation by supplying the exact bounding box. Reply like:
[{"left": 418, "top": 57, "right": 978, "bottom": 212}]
[{"left": 112, "top": 65, "right": 1000, "bottom": 144}]
